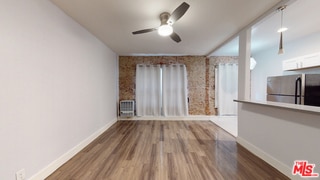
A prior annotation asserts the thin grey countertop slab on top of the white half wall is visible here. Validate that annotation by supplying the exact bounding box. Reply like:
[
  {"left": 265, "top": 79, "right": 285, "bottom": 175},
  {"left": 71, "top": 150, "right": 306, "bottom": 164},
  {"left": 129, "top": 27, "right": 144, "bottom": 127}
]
[{"left": 234, "top": 100, "right": 320, "bottom": 114}]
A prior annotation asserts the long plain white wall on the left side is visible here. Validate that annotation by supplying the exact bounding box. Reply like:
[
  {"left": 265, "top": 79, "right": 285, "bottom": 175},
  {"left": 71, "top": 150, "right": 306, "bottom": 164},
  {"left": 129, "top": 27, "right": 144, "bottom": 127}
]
[{"left": 0, "top": 0, "right": 117, "bottom": 180}]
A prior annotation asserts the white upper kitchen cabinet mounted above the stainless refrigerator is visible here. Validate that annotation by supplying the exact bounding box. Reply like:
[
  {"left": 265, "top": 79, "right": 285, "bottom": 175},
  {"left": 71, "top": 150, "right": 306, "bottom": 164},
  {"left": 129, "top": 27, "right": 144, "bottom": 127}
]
[{"left": 282, "top": 52, "right": 320, "bottom": 71}]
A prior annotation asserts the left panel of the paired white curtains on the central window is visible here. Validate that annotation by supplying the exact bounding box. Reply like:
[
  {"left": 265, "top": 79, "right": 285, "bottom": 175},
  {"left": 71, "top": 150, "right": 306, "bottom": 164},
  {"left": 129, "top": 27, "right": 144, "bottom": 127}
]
[{"left": 136, "top": 64, "right": 161, "bottom": 116}]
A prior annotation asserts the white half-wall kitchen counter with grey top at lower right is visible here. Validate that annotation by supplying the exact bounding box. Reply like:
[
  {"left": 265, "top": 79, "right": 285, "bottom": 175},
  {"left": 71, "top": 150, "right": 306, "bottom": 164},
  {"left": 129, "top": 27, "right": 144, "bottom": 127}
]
[{"left": 235, "top": 100, "right": 320, "bottom": 179}]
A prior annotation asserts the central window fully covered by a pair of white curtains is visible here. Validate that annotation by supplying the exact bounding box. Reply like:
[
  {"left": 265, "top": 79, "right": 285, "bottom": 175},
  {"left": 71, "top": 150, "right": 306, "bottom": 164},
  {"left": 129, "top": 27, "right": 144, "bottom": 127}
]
[{"left": 136, "top": 64, "right": 188, "bottom": 116}]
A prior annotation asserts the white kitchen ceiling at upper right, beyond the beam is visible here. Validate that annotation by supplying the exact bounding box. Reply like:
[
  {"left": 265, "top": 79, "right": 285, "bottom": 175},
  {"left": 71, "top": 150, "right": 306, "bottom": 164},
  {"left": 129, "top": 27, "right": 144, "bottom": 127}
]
[{"left": 211, "top": 0, "right": 320, "bottom": 56}]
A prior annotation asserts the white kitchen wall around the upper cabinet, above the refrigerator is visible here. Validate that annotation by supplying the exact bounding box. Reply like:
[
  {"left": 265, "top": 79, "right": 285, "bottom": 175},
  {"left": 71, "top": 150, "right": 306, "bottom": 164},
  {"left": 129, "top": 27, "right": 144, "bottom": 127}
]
[{"left": 251, "top": 32, "right": 320, "bottom": 100}]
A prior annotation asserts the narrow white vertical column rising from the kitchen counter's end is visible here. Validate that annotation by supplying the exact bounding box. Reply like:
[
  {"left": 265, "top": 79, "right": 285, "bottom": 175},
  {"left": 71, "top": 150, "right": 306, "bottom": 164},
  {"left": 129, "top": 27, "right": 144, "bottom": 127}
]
[{"left": 238, "top": 28, "right": 251, "bottom": 100}]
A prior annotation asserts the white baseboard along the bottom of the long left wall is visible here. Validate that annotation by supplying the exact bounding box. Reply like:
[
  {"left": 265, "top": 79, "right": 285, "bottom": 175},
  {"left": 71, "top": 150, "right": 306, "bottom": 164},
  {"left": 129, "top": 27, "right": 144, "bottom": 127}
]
[{"left": 29, "top": 119, "right": 117, "bottom": 180}]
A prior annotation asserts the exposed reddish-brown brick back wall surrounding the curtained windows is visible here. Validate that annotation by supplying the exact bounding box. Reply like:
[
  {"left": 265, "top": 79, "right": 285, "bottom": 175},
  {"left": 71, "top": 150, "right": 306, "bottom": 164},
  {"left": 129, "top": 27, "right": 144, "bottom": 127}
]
[{"left": 119, "top": 56, "right": 237, "bottom": 115}]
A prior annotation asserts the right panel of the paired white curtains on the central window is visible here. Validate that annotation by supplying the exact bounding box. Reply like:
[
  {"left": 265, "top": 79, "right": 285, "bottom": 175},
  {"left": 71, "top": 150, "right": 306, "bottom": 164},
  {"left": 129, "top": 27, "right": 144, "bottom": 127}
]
[{"left": 162, "top": 65, "right": 188, "bottom": 116}]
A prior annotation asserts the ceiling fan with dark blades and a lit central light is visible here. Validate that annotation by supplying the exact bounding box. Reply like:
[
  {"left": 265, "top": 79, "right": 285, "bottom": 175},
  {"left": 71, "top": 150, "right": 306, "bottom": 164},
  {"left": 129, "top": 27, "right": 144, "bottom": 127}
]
[{"left": 132, "top": 2, "right": 190, "bottom": 43}]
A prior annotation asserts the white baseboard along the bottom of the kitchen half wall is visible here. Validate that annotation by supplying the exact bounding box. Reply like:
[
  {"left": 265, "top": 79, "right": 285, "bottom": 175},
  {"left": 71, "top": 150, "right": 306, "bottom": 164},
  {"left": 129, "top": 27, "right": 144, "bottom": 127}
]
[{"left": 237, "top": 137, "right": 300, "bottom": 179}]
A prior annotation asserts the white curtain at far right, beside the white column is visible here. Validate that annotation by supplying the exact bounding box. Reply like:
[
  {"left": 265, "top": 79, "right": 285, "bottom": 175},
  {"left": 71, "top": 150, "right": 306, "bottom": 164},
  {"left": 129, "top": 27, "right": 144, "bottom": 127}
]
[{"left": 215, "top": 63, "right": 238, "bottom": 115}]
